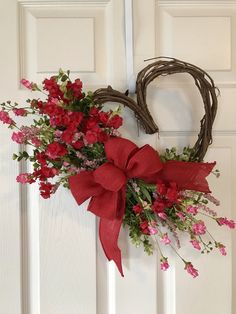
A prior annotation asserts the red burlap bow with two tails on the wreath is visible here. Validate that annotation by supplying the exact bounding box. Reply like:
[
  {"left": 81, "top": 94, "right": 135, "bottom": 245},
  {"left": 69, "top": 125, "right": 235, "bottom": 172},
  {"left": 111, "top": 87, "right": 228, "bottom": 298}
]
[{"left": 69, "top": 138, "right": 215, "bottom": 276}]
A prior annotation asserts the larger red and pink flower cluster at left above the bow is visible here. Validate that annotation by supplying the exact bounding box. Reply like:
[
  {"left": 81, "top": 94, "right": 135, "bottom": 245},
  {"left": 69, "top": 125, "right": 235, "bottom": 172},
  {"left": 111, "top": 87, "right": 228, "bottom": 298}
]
[{"left": 0, "top": 71, "right": 122, "bottom": 198}]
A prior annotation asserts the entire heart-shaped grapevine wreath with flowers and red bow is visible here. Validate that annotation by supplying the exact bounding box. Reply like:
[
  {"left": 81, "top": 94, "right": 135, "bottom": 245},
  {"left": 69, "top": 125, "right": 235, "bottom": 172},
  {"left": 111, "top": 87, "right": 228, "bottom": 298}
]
[{"left": 0, "top": 58, "right": 235, "bottom": 277}]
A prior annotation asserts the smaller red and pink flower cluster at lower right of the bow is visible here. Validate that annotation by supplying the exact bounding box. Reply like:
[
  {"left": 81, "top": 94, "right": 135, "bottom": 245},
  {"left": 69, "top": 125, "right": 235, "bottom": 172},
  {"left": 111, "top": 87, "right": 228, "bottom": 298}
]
[{"left": 123, "top": 155, "right": 235, "bottom": 278}]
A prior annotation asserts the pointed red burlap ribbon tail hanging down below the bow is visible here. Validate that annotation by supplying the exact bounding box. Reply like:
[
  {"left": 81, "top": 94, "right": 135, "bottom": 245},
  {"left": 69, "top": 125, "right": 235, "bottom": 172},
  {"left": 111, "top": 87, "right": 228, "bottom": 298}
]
[{"left": 99, "top": 188, "right": 126, "bottom": 277}]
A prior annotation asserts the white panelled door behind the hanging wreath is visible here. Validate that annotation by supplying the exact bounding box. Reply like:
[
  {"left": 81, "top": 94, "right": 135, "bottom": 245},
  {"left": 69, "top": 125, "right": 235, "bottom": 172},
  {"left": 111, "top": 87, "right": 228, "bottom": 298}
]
[{"left": 0, "top": 0, "right": 236, "bottom": 314}]
